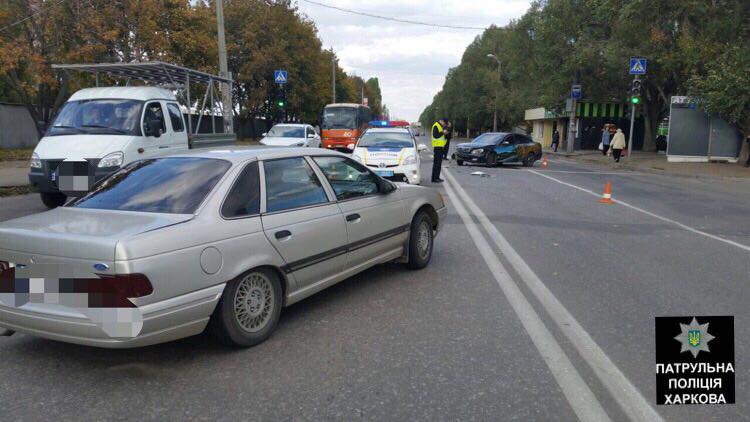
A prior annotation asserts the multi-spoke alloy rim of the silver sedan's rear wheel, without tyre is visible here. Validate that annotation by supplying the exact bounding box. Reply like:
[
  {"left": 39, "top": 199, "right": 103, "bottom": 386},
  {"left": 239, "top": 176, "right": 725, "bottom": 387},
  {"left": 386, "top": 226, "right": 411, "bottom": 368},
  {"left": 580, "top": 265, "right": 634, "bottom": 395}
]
[{"left": 234, "top": 273, "right": 274, "bottom": 333}]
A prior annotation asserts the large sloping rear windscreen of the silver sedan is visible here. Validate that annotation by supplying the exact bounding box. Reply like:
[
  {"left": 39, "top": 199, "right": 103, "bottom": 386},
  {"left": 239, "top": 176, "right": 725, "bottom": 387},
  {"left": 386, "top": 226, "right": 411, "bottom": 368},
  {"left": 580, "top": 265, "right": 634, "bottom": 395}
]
[{"left": 71, "top": 157, "right": 230, "bottom": 214}]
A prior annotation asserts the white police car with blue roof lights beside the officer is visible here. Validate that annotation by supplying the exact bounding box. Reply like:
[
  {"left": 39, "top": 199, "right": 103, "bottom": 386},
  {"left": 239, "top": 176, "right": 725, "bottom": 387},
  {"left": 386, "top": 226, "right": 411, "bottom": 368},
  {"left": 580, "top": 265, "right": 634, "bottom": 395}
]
[{"left": 352, "top": 127, "right": 427, "bottom": 185}]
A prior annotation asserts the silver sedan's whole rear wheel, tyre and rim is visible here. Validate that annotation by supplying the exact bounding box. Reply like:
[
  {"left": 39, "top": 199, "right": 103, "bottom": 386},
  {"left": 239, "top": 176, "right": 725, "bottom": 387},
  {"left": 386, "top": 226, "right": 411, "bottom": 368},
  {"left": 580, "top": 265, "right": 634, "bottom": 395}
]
[{"left": 209, "top": 268, "right": 282, "bottom": 347}]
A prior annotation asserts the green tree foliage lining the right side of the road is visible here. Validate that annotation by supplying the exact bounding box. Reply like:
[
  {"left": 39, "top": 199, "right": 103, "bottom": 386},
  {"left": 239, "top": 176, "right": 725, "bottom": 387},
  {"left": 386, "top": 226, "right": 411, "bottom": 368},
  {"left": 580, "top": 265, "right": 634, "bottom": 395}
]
[{"left": 420, "top": 0, "right": 750, "bottom": 149}]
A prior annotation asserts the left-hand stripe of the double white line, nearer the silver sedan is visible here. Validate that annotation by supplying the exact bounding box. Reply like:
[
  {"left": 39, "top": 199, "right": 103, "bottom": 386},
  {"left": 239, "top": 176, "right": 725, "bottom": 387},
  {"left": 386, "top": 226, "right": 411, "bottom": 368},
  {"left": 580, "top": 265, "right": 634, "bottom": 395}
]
[{"left": 444, "top": 176, "right": 610, "bottom": 421}]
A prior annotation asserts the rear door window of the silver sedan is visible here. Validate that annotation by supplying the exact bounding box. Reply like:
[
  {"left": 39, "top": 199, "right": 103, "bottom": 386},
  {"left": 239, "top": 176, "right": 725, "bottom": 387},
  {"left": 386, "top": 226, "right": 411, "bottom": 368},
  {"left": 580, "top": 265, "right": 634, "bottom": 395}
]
[{"left": 263, "top": 157, "right": 328, "bottom": 212}]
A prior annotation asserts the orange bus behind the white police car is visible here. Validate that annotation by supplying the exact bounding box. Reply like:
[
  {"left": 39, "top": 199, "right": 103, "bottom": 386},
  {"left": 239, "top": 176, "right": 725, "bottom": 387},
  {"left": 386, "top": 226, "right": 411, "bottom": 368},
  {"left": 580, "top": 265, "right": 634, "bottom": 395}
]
[{"left": 320, "top": 103, "right": 371, "bottom": 149}]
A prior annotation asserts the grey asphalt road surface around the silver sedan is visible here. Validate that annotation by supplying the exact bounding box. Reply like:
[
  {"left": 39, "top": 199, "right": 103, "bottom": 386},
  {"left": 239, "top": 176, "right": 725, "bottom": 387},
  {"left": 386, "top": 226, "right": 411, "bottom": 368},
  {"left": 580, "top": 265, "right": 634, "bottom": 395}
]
[{"left": 0, "top": 147, "right": 750, "bottom": 420}]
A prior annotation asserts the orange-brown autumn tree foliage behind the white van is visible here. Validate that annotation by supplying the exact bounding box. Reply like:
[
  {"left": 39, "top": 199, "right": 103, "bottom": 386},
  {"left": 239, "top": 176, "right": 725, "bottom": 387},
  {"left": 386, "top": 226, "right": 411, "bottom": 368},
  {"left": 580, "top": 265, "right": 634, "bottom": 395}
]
[{"left": 0, "top": 0, "right": 382, "bottom": 134}]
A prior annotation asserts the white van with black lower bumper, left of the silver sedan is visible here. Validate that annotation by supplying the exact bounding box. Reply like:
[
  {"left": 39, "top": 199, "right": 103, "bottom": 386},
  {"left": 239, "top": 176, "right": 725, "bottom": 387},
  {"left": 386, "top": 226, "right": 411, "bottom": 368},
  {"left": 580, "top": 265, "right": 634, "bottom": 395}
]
[{"left": 29, "top": 65, "right": 235, "bottom": 208}]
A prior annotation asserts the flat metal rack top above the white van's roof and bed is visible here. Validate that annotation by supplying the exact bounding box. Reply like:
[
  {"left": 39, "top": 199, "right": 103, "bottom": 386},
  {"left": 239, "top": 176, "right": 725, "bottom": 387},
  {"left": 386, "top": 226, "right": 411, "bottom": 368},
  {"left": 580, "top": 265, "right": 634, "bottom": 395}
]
[{"left": 52, "top": 62, "right": 232, "bottom": 86}]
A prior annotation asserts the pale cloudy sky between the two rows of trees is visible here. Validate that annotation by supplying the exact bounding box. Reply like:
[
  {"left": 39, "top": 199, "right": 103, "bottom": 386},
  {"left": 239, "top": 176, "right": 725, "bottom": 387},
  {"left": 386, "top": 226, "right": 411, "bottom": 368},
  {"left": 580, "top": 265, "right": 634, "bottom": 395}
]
[{"left": 297, "top": 0, "right": 530, "bottom": 121}]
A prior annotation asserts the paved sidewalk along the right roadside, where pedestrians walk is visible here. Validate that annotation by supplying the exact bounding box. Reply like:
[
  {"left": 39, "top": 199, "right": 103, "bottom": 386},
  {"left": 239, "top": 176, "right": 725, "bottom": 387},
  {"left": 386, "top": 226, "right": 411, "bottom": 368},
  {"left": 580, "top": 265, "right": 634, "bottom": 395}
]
[{"left": 544, "top": 149, "right": 750, "bottom": 179}]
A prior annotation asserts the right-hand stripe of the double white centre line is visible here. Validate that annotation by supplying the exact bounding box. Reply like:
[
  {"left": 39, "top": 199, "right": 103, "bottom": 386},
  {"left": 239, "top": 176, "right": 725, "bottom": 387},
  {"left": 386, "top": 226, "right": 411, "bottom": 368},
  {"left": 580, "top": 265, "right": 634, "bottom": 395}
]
[{"left": 445, "top": 171, "right": 662, "bottom": 421}]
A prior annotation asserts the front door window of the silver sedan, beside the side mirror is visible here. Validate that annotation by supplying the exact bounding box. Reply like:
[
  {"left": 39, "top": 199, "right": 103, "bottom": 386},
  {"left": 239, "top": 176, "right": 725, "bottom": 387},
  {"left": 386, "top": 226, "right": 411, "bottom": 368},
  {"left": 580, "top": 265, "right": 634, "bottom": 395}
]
[{"left": 313, "top": 157, "right": 378, "bottom": 200}]
